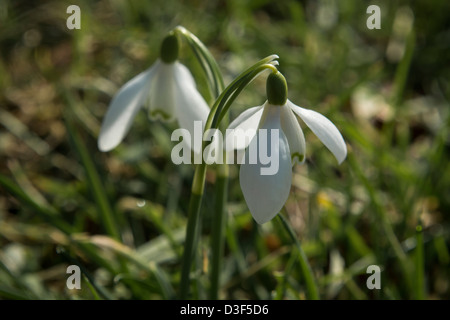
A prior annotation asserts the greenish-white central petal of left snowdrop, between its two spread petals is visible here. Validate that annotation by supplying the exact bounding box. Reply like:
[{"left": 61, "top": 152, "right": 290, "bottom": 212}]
[{"left": 148, "top": 60, "right": 177, "bottom": 121}]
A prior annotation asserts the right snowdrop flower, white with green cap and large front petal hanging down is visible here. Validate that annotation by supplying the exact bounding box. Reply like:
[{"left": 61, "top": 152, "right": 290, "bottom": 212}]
[{"left": 229, "top": 72, "right": 347, "bottom": 224}]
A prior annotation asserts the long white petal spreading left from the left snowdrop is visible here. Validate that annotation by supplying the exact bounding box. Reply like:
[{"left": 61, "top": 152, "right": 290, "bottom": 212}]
[{"left": 98, "top": 63, "right": 158, "bottom": 151}]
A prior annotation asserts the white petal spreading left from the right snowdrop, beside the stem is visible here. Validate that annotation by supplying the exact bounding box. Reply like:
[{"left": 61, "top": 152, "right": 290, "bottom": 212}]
[{"left": 225, "top": 106, "right": 264, "bottom": 151}]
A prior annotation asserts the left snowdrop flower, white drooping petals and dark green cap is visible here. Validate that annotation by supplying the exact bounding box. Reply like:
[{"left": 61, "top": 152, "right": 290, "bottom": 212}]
[{"left": 98, "top": 34, "right": 209, "bottom": 153}]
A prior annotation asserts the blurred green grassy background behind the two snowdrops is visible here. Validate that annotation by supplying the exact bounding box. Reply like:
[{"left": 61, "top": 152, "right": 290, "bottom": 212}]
[{"left": 0, "top": 0, "right": 450, "bottom": 299}]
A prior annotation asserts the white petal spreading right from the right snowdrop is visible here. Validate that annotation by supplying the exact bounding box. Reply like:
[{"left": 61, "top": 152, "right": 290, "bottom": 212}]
[{"left": 286, "top": 100, "right": 347, "bottom": 164}]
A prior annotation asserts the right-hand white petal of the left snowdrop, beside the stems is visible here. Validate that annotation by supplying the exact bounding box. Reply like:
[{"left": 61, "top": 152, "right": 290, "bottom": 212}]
[{"left": 174, "top": 62, "right": 210, "bottom": 154}]
